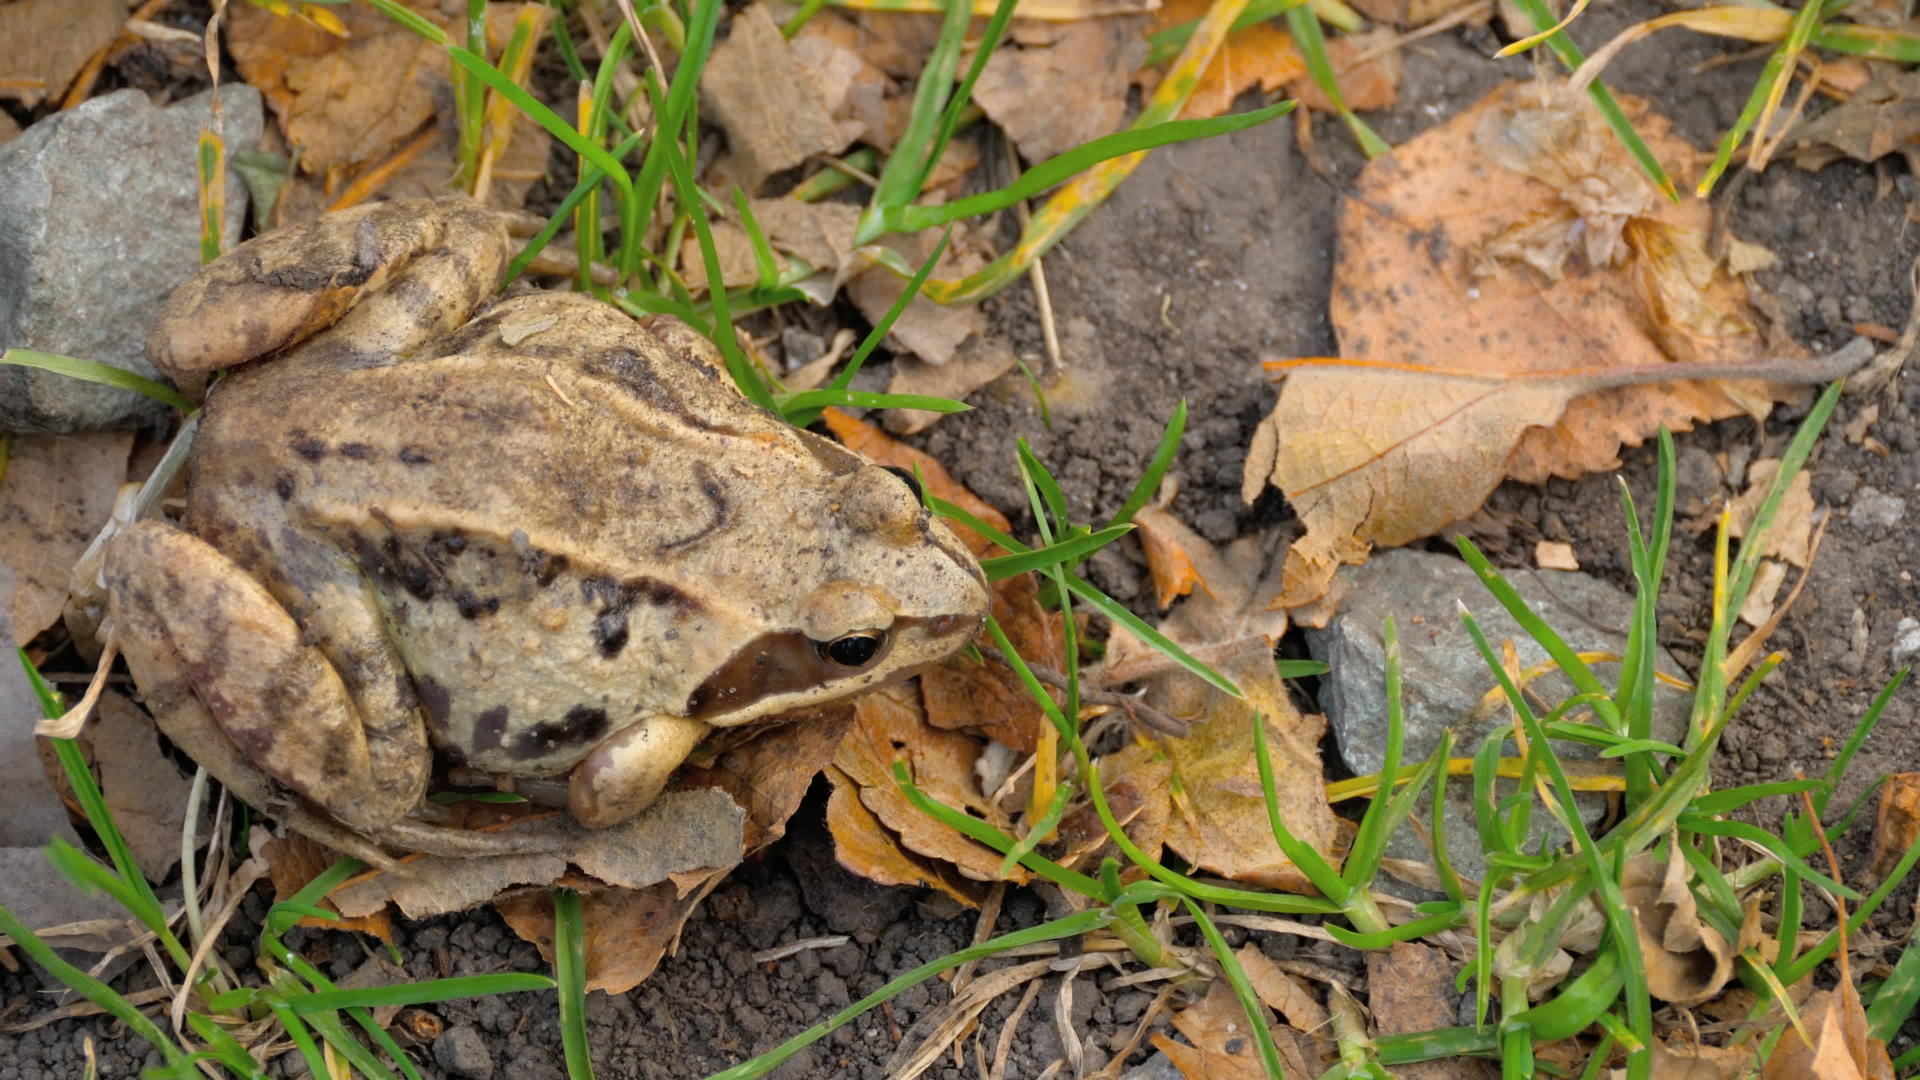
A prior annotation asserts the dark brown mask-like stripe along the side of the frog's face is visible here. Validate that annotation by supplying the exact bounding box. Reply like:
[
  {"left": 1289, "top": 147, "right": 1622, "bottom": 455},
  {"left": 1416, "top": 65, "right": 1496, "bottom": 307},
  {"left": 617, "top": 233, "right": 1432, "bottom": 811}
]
[{"left": 685, "top": 615, "right": 979, "bottom": 723}]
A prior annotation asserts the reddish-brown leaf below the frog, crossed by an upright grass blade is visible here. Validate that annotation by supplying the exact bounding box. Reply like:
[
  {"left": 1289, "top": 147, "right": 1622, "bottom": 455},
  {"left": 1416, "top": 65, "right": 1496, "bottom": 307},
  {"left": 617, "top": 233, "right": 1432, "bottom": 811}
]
[{"left": 493, "top": 871, "right": 726, "bottom": 994}]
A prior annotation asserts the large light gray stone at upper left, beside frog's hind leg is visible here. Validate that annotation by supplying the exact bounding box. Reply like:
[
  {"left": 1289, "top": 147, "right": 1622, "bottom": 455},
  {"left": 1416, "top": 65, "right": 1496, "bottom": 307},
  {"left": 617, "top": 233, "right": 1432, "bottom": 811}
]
[{"left": 0, "top": 85, "right": 261, "bottom": 432}]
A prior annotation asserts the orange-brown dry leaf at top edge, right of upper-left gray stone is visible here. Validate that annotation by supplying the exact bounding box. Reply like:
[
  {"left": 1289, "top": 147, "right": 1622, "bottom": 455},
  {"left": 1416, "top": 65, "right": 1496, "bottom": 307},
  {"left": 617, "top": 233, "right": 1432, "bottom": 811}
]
[{"left": 227, "top": 0, "right": 449, "bottom": 173}]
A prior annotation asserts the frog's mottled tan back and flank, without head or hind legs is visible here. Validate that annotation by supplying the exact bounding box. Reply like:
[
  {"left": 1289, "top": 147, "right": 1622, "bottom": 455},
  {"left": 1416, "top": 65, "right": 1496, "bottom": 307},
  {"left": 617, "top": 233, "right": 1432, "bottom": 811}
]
[{"left": 188, "top": 294, "right": 862, "bottom": 774}]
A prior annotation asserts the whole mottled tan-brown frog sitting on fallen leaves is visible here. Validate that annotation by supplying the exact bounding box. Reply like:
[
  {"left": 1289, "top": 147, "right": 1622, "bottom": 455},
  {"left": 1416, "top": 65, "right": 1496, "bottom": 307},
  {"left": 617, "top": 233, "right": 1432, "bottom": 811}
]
[{"left": 104, "top": 198, "right": 989, "bottom": 855}]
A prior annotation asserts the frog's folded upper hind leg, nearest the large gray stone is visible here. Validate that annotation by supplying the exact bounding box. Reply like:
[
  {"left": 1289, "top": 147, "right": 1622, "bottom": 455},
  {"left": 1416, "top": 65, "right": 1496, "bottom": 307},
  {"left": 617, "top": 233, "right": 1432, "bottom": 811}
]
[{"left": 146, "top": 196, "right": 509, "bottom": 390}]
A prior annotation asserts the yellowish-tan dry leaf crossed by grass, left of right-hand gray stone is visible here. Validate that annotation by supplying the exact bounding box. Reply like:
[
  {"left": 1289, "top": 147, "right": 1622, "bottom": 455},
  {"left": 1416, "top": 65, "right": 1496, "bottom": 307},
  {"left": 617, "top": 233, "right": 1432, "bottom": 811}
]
[{"left": 1148, "top": 650, "right": 1340, "bottom": 892}]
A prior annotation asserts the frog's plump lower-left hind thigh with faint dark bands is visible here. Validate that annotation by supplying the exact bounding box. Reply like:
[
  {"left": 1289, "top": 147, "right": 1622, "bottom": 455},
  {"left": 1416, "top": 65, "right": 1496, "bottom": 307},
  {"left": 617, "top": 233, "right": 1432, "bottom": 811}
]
[{"left": 108, "top": 521, "right": 424, "bottom": 830}]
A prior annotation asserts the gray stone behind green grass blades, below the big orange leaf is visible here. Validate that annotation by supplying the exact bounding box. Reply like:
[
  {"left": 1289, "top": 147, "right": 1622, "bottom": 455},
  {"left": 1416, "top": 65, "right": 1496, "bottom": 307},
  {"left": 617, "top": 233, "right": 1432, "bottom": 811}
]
[{"left": 1308, "top": 550, "right": 1692, "bottom": 878}]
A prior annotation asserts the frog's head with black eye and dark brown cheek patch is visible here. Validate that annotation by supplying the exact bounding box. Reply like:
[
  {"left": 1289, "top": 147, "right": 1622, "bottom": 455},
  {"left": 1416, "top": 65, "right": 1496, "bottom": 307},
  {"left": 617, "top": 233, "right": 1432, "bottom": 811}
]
[{"left": 687, "top": 461, "right": 991, "bottom": 726}]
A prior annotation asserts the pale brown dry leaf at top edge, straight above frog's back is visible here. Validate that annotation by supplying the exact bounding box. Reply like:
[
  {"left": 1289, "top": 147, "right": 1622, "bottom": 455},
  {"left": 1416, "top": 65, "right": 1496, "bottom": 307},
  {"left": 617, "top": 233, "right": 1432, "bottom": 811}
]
[{"left": 701, "top": 4, "right": 860, "bottom": 194}]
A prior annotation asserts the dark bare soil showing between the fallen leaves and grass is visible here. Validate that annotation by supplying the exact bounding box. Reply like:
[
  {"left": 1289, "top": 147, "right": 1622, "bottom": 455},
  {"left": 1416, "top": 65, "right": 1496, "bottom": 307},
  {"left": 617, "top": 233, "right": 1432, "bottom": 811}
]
[{"left": 0, "top": 0, "right": 1920, "bottom": 1080}]
